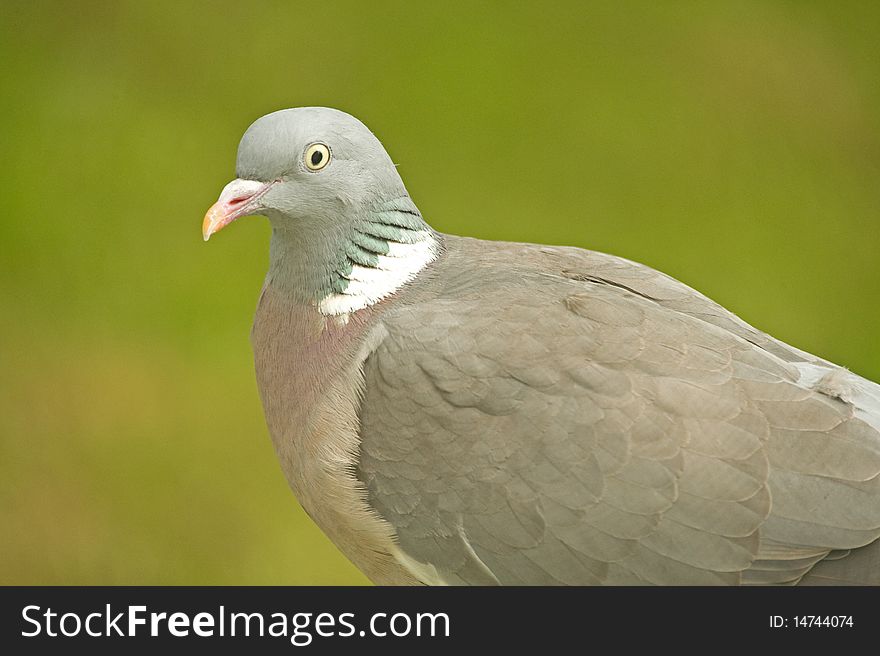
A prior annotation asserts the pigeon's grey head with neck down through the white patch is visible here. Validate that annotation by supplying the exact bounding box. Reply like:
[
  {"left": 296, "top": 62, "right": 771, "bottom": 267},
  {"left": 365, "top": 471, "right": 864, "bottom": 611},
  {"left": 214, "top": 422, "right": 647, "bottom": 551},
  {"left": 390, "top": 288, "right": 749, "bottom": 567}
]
[{"left": 202, "top": 107, "right": 438, "bottom": 314}]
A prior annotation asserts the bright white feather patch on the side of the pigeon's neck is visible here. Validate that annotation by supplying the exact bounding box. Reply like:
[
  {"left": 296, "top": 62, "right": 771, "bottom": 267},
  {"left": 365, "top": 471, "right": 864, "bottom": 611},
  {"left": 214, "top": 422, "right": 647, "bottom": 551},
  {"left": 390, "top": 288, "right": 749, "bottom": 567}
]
[{"left": 318, "top": 230, "right": 440, "bottom": 316}]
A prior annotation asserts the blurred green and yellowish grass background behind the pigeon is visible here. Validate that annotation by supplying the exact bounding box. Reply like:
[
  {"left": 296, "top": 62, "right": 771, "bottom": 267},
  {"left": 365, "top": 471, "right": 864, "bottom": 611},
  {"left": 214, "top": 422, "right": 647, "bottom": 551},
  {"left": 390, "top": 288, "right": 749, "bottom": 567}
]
[{"left": 0, "top": 0, "right": 880, "bottom": 584}]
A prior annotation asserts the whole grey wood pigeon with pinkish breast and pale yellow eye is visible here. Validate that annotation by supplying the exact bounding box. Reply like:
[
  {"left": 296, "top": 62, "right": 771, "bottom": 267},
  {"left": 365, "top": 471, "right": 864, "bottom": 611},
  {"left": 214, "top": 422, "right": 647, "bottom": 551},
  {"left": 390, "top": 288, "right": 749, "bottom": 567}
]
[{"left": 202, "top": 107, "right": 880, "bottom": 586}]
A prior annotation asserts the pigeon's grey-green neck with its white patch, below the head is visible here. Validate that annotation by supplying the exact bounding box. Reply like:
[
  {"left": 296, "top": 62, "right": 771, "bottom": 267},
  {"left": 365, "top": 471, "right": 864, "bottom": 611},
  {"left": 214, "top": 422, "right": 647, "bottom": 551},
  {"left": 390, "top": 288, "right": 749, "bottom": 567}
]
[{"left": 268, "top": 196, "right": 440, "bottom": 316}]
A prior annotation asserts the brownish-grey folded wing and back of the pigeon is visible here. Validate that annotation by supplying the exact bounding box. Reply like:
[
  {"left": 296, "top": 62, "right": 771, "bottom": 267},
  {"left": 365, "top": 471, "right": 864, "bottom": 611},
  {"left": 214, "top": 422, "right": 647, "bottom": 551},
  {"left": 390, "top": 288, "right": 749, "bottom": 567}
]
[{"left": 358, "top": 240, "right": 880, "bottom": 585}]
